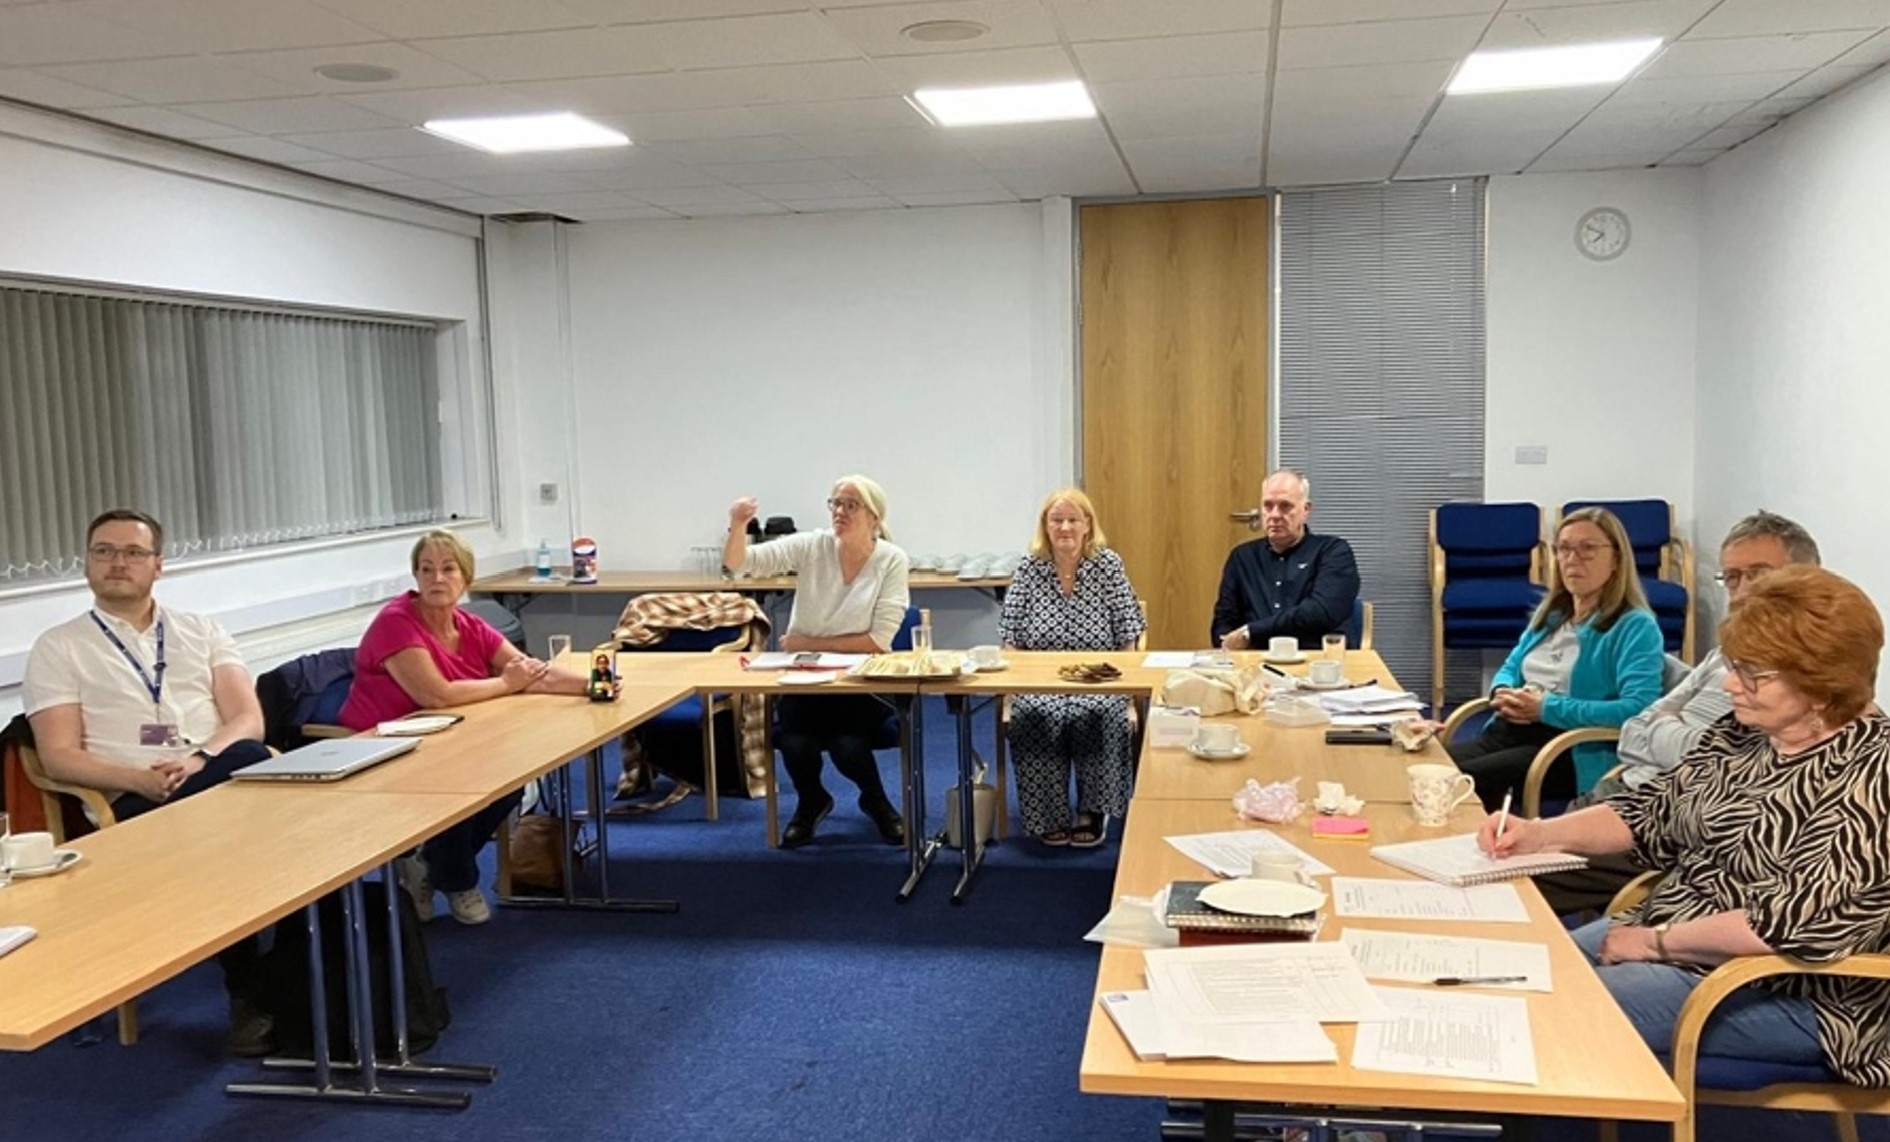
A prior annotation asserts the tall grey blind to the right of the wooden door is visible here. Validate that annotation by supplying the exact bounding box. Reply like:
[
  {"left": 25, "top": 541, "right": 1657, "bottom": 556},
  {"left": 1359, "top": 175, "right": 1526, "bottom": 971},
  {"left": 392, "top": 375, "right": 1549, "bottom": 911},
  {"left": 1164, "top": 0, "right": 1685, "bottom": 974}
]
[{"left": 1278, "top": 180, "right": 1484, "bottom": 710}]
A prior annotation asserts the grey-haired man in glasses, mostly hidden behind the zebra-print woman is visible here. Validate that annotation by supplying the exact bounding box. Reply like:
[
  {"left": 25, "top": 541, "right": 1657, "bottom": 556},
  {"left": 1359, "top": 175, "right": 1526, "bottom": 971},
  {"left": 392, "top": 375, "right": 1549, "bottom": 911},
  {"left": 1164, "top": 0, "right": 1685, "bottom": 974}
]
[{"left": 1535, "top": 510, "right": 1818, "bottom": 913}]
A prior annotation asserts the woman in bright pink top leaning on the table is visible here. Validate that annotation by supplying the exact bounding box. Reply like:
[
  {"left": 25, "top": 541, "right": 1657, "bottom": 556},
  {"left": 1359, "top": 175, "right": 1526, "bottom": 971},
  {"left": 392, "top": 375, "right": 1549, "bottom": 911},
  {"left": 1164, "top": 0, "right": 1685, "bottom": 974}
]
[{"left": 340, "top": 529, "right": 590, "bottom": 925}]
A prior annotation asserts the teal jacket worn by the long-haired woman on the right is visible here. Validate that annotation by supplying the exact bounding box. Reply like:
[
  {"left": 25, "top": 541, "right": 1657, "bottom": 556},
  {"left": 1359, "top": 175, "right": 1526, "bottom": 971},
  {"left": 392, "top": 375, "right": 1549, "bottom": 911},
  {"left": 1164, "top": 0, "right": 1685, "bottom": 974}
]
[{"left": 1491, "top": 609, "right": 1665, "bottom": 792}]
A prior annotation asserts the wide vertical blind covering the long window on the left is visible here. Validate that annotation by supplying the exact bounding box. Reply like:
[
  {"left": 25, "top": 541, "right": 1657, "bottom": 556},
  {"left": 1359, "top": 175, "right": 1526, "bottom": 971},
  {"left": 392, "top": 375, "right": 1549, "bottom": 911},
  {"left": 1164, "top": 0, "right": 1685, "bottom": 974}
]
[{"left": 0, "top": 286, "right": 444, "bottom": 582}]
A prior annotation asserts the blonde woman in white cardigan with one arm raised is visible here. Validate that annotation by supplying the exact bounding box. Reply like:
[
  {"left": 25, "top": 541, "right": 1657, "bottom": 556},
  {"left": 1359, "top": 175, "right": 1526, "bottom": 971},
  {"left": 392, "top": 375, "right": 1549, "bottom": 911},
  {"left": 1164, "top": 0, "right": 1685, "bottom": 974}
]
[{"left": 722, "top": 476, "right": 911, "bottom": 849}]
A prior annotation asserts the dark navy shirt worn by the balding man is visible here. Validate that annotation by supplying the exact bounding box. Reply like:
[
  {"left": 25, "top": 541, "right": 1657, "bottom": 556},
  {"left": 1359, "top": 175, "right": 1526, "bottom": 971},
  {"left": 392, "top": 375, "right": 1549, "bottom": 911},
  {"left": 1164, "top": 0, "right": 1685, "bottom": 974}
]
[{"left": 1210, "top": 529, "right": 1359, "bottom": 649}]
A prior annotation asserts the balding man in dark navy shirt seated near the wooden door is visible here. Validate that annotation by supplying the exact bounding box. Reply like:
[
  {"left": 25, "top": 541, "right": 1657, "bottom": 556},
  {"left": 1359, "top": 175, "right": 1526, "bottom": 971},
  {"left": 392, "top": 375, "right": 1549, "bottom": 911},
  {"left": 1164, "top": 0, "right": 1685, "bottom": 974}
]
[{"left": 1211, "top": 469, "right": 1359, "bottom": 650}]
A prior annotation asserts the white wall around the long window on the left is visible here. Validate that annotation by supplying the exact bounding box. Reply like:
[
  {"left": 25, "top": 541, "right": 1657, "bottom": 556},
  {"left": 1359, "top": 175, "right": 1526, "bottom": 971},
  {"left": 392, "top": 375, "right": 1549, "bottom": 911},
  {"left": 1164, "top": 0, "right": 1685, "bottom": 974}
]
[{"left": 0, "top": 108, "right": 518, "bottom": 715}]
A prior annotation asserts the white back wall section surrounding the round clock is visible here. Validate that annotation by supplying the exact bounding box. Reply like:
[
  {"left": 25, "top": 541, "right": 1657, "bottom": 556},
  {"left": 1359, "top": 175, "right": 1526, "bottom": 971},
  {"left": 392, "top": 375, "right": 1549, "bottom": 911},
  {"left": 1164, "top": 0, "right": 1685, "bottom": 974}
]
[{"left": 1484, "top": 168, "right": 1701, "bottom": 546}]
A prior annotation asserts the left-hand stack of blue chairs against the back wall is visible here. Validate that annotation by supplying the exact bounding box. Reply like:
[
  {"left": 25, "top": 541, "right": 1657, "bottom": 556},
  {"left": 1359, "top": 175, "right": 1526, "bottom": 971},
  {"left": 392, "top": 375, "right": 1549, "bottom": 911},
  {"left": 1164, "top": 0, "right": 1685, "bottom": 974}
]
[{"left": 1431, "top": 503, "right": 1548, "bottom": 713}]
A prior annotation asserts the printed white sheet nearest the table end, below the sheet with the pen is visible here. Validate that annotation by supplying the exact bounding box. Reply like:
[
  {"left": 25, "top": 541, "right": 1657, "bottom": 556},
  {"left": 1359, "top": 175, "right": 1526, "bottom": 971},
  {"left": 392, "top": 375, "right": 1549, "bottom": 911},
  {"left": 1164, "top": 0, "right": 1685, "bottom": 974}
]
[{"left": 1351, "top": 987, "right": 1537, "bottom": 1083}]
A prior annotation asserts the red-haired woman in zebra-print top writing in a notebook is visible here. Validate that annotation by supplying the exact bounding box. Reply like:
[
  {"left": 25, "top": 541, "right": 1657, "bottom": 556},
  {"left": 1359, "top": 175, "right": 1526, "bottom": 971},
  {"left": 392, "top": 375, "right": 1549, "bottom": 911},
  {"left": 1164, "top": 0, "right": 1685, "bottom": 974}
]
[{"left": 1480, "top": 567, "right": 1890, "bottom": 1087}]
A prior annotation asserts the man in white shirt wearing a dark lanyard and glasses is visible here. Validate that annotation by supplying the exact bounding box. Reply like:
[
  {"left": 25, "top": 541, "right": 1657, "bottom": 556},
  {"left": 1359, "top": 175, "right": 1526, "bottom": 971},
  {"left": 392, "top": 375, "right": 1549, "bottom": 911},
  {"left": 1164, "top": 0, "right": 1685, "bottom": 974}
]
[{"left": 23, "top": 509, "right": 270, "bottom": 1055}]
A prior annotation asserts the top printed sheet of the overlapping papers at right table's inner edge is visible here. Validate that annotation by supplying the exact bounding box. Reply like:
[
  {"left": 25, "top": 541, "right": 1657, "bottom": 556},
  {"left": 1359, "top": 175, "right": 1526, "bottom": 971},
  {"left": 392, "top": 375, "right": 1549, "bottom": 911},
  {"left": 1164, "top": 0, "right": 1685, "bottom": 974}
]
[{"left": 1142, "top": 943, "right": 1385, "bottom": 1025}]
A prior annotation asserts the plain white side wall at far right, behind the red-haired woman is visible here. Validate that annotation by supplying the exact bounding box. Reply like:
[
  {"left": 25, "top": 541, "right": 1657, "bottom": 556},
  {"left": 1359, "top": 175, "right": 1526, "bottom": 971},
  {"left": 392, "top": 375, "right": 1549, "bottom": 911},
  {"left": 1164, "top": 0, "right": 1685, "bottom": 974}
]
[{"left": 1697, "top": 72, "right": 1890, "bottom": 654}]
